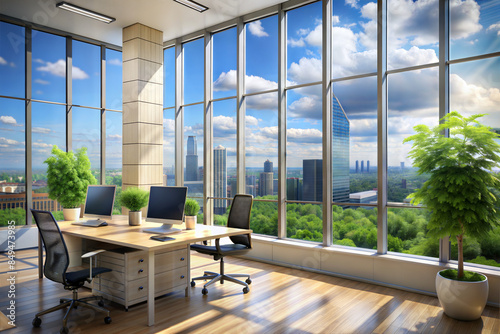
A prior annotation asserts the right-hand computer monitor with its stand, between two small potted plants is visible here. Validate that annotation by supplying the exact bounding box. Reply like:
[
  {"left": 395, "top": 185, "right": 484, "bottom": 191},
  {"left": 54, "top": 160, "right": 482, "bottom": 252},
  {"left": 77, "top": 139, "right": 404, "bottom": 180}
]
[{"left": 144, "top": 186, "right": 187, "bottom": 234}]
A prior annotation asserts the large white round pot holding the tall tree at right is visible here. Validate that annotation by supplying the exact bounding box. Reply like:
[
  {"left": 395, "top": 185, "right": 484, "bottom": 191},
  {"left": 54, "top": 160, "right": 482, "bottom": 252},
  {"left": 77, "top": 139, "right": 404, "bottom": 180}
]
[{"left": 436, "top": 272, "right": 488, "bottom": 321}]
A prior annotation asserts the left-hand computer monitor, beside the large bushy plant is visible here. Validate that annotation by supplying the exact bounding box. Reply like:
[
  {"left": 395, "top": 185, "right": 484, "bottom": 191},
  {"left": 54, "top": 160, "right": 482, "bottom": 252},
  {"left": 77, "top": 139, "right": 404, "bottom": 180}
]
[{"left": 83, "top": 185, "right": 116, "bottom": 219}]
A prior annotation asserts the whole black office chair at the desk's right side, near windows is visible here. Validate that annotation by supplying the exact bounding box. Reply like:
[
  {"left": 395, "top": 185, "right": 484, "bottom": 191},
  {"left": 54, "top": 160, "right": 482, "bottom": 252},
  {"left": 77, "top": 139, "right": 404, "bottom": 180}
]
[{"left": 191, "top": 194, "right": 253, "bottom": 295}]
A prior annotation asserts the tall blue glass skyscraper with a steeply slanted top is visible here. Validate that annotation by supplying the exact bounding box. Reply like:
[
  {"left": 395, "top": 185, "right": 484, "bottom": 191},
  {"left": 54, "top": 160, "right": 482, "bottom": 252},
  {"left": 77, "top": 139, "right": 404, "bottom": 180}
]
[{"left": 332, "top": 95, "right": 352, "bottom": 203}]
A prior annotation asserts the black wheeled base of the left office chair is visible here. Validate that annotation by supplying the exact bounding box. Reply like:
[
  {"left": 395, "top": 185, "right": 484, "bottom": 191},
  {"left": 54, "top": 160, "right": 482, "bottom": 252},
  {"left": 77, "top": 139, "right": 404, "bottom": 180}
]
[{"left": 32, "top": 290, "right": 111, "bottom": 333}]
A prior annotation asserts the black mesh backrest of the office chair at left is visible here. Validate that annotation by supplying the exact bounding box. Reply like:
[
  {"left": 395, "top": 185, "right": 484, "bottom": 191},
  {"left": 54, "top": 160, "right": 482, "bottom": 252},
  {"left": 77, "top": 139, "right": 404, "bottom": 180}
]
[{"left": 31, "top": 210, "right": 69, "bottom": 285}]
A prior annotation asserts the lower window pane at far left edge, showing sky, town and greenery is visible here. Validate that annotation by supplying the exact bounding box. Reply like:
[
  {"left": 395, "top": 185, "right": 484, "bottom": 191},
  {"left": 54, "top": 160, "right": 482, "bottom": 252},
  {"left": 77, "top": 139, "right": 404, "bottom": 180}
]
[{"left": 0, "top": 98, "right": 26, "bottom": 227}]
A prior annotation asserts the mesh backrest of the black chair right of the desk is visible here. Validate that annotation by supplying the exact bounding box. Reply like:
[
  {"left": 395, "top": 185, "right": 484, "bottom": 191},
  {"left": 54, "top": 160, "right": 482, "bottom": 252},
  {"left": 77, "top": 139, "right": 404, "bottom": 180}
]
[{"left": 227, "top": 194, "right": 253, "bottom": 248}]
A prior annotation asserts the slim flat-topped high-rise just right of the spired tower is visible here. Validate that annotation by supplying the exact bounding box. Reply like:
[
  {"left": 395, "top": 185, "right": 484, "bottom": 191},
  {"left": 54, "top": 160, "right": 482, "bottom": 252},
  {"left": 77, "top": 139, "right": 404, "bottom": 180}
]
[{"left": 214, "top": 145, "right": 227, "bottom": 215}]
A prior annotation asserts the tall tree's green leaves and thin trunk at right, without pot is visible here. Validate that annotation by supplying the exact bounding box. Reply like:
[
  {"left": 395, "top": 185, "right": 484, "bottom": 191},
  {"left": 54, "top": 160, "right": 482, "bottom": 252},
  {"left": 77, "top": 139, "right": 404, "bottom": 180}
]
[{"left": 404, "top": 111, "right": 500, "bottom": 279}]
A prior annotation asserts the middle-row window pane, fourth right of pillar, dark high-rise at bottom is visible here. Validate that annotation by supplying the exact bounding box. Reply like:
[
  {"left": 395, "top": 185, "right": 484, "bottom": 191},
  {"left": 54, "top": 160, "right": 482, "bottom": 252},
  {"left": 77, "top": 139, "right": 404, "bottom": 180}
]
[{"left": 245, "top": 93, "right": 278, "bottom": 199}]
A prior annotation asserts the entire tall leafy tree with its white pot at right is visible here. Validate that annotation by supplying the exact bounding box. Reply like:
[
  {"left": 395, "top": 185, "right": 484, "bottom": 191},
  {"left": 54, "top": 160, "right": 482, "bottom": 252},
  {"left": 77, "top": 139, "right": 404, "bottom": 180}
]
[{"left": 404, "top": 112, "right": 500, "bottom": 320}]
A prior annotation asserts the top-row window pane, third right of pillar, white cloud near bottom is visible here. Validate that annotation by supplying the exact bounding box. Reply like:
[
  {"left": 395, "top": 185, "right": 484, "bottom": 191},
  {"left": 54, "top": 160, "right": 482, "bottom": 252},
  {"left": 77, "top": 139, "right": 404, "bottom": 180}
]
[{"left": 212, "top": 28, "right": 236, "bottom": 99}]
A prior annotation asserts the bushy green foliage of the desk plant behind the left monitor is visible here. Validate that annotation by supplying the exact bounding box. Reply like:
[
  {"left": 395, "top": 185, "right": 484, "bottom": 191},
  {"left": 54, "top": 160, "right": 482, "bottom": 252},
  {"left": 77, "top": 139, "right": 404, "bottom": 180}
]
[{"left": 45, "top": 145, "right": 97, "bottom": 208}]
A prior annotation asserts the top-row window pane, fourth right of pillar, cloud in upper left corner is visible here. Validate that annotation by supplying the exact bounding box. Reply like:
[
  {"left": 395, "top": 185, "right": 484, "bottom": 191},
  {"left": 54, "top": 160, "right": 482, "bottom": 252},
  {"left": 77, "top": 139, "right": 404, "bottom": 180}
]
[{"left": 245, "top": 15, "right": 278, "bottom": 93}]
